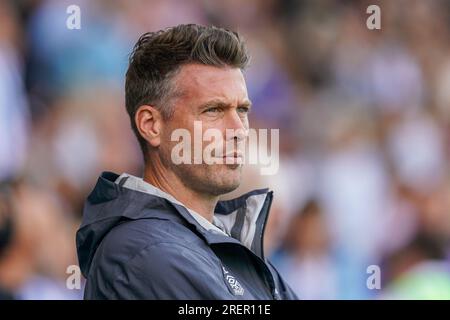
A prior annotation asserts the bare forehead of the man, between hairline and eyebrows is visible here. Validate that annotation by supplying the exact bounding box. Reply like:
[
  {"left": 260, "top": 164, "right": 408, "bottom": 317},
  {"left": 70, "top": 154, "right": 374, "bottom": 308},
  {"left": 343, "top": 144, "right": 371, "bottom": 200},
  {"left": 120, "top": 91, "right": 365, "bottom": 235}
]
[{"left": 175, "top": 64, "right": 248, "bottom": 104}]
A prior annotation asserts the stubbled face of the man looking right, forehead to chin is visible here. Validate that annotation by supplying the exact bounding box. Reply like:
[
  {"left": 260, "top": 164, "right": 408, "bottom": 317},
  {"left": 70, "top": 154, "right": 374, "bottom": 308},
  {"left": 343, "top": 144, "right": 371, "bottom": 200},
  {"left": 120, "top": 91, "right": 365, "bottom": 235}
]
[{"left": 160, "top": 64, "right": 250, "bottom": 196}]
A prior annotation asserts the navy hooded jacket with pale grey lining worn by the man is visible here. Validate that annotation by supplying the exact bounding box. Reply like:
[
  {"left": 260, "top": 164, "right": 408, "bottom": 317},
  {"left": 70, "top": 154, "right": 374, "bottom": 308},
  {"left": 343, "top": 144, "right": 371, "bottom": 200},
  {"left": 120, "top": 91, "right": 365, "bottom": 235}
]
[{"left": 76, "top": 172, "right": 296, "bottom": 299}]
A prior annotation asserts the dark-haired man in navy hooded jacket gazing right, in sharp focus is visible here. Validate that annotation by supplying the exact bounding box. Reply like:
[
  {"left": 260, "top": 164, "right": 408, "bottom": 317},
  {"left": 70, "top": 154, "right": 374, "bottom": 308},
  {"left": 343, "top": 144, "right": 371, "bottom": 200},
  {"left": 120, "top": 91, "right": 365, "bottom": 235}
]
[{"left": 77, "top": 25, "right": 296, "bottom": 299}]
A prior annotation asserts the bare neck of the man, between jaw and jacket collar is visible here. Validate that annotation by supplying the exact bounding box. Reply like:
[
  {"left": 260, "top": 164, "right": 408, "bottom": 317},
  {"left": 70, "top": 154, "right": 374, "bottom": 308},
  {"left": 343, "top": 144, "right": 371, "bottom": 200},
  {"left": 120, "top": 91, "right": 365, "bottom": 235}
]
[{"left": 143, "top": 158, "right": 218, "bottom": 223}]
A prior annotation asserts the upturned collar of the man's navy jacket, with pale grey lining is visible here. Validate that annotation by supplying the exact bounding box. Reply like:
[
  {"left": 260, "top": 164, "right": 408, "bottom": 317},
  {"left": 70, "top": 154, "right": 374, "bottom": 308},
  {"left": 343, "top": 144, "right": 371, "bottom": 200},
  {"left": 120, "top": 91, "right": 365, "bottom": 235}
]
[{"left": 89, "top": 172, "right": 273, "bottom": 260}]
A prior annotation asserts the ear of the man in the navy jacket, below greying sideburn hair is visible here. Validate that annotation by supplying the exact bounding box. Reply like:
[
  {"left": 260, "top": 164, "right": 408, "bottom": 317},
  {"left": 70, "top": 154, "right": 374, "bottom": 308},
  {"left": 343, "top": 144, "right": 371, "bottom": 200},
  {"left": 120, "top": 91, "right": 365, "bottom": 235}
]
[{"left": 134, "top": 105, "right": 162, "bottom": 147}]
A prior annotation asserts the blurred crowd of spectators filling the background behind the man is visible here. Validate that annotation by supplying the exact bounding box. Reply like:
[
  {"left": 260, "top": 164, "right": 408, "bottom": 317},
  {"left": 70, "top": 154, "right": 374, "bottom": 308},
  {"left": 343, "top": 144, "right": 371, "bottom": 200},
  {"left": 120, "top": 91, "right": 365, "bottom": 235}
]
[{"left": 0, "top": 0, "right": 450, "bottom": 299}]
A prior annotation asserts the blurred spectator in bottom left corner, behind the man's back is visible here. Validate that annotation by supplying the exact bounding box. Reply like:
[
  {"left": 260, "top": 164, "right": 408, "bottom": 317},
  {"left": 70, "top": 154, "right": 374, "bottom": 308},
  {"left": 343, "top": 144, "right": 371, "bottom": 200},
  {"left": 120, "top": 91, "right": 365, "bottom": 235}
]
[{"left": 0, "top": 181, "right": 81, "bottom": 299}]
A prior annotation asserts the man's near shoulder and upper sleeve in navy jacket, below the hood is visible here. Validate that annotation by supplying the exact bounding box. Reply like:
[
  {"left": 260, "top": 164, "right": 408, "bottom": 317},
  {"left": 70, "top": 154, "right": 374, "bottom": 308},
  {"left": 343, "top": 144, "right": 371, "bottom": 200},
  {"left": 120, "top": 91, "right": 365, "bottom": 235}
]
[{"left": 87, "top": 219, "right": 229, "bottom": 299}]
